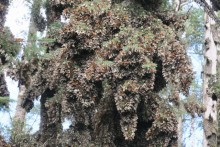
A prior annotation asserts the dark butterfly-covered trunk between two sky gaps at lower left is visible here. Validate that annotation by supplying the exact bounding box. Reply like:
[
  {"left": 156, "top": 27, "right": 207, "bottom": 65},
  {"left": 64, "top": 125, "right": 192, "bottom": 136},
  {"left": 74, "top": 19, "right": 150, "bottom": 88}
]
[{"left": 39, "top": 90, "right": 62, "bottom": 146}]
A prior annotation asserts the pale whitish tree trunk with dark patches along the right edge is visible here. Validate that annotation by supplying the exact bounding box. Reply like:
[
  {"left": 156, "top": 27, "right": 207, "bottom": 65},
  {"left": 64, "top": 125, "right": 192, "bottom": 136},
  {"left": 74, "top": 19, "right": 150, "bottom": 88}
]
[{"left": 203, "top": 0, "right": 217, "bottom": 147}]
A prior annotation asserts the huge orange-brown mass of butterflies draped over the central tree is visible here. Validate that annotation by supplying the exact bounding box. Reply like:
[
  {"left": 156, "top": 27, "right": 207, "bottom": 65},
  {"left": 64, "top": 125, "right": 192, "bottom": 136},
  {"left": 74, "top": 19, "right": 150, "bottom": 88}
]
[{"left": 9, "top": 0, "right": 193, "bottom": 146}]
